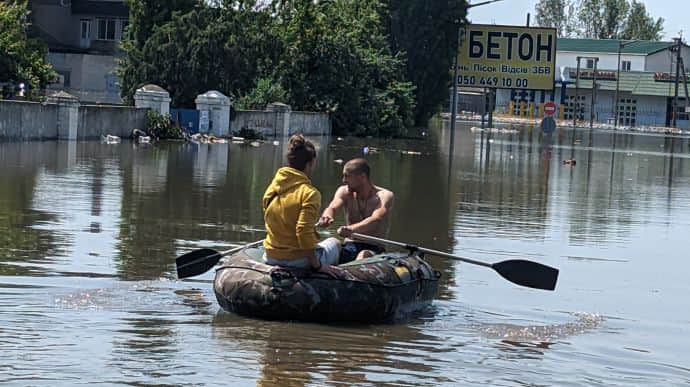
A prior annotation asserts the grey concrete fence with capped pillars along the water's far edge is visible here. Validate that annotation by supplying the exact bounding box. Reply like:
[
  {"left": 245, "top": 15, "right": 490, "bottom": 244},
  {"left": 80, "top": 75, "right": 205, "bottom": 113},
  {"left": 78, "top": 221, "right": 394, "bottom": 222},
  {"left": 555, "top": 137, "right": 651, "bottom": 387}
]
[{"left": 0, "top": 85, "right": 331, "bottom": 141}]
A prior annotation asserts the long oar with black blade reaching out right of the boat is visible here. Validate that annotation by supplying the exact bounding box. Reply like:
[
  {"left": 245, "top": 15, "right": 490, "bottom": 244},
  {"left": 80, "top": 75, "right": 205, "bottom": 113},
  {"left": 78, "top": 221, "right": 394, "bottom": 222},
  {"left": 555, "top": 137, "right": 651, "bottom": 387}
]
[{"left": 352, "top": 233, "right": 558, "bottom": 290}]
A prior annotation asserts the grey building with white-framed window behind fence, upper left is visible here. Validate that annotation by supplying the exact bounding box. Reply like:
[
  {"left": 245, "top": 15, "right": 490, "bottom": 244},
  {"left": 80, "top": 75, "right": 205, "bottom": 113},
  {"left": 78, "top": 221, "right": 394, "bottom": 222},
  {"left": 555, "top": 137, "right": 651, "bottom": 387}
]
[{"left": 29, "top": 0, "right": 129, "bottom": 104}]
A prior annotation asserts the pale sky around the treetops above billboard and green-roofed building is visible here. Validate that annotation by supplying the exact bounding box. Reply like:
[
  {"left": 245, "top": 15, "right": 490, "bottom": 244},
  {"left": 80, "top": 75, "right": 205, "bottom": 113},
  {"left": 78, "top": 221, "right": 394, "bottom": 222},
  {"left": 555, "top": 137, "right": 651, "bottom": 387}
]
[{"left": 468, "top": 0, "right": 690, "bottom": 40}]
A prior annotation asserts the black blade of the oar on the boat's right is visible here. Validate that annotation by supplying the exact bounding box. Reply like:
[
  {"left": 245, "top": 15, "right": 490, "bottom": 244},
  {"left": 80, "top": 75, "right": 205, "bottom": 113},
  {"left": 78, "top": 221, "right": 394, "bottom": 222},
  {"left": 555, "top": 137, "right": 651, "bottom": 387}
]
[{"left": 491, "top": 259, "right": 558, "bottom": 290}]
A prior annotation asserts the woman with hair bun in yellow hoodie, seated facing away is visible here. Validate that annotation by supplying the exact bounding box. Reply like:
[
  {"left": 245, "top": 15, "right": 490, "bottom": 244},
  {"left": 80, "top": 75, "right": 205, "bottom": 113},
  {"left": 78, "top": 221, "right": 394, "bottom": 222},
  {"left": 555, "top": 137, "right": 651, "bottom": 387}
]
[{"left": 263, "top": 134, "right": 340, "bottom": 274}]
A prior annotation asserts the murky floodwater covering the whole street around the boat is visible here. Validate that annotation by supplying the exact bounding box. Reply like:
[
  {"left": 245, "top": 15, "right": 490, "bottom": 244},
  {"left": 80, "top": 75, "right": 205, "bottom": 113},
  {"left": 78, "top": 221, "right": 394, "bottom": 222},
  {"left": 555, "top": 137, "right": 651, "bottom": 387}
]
[{"left": 0, "top": 124, "right": 690, "bottom": 386}]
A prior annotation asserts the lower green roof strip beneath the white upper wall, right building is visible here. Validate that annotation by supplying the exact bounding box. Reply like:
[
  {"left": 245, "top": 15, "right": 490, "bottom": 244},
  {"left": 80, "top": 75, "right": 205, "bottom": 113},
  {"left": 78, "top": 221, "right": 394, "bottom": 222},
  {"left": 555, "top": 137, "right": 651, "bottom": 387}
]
[{"left": 568, "top": 68, "right": 684, "bottom": 97}]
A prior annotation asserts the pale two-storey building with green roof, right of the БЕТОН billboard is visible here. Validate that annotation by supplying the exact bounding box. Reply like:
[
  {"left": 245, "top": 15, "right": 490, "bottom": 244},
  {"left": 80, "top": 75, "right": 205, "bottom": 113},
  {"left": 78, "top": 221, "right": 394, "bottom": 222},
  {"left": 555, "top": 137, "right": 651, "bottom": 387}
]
[{"left": 496, "top": 39, "right": 690, "bottom": 128}]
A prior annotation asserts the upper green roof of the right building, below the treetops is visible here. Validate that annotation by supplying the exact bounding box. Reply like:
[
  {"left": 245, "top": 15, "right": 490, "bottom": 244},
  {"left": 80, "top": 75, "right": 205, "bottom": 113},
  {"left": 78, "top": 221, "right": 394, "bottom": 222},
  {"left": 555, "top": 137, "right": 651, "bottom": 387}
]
[{"left": 557, "top": 38, "right": 676, "bottom": 55}]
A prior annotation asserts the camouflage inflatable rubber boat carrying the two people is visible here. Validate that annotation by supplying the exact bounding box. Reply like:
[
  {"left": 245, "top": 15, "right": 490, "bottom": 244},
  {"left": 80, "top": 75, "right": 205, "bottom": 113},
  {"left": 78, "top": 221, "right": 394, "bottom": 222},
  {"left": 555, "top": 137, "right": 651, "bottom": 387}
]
[{"left": 213, "top": 249, "right": 441, "bottom": 322}]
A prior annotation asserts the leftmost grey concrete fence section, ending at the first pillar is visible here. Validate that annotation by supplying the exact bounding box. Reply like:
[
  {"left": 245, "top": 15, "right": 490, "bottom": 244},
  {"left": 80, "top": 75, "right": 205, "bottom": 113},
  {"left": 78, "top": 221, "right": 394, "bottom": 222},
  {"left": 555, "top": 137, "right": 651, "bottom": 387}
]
[{"left": 0, "top": 100, "right": 57, "bottom": 140}]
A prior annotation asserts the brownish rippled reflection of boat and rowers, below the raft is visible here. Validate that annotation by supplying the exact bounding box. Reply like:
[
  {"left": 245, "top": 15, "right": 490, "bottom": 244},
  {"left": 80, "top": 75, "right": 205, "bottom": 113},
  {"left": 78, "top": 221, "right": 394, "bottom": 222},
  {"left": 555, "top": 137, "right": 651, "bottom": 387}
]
[{"left": 212, "top": 312, "right": 450, "bottom": 386}]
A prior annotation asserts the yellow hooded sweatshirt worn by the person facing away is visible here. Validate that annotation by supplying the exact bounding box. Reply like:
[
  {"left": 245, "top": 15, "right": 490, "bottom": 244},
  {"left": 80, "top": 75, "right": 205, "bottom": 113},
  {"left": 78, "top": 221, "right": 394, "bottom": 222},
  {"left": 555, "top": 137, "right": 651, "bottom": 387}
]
[{"left": 263, "top": 167, "right": 321, "bottom": 260}]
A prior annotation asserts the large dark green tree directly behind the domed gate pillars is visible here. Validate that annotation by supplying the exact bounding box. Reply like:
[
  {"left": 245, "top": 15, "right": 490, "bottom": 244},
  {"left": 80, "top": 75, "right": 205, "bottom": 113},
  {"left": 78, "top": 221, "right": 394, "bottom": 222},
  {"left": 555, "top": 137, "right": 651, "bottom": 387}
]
[{"left": 118, "top": 1, "right": 280, "bottom": 106}]
